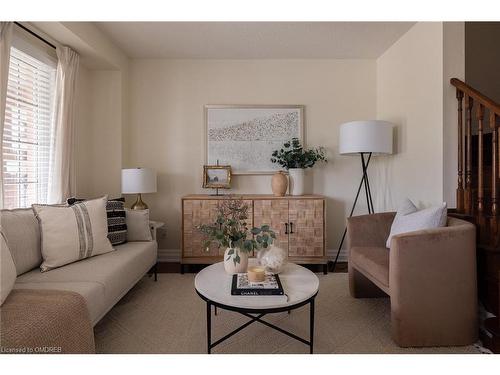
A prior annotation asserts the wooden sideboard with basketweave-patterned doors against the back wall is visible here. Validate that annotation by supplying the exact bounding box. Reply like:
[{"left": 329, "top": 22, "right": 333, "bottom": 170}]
[{"left": 181, "top": 194, "right": 327, "bottom": 272}]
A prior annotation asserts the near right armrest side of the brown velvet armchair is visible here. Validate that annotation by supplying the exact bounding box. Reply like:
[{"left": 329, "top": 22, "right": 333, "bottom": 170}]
[{"left": 389, "top": 218, "right": 477, "bottom": 346}]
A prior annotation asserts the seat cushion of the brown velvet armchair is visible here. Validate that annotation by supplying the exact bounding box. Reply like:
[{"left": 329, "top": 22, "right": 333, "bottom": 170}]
[{"left": 349, "top": 246, "right": 389, "bottom": 292}]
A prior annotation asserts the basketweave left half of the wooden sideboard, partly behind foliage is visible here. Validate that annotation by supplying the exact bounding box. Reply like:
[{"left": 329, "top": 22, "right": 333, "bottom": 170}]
[{"left": 182, "top": 199, "right": 253, "bottom": 258}]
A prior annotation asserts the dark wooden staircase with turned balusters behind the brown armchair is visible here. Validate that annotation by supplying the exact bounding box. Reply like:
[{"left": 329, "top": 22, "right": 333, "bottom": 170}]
[{"left": 450, "top": 78, "right": 500, "bottom": 353}]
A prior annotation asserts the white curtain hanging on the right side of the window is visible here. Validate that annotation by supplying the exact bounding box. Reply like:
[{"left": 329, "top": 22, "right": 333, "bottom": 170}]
[{"left": 48, "top": 47, "right": 79, "bottom": 203}]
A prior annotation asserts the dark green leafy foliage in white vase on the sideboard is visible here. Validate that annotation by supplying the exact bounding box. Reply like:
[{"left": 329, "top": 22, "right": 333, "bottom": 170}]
[{"left": 271, "top": 138, "right": 327, "bottom": 169}]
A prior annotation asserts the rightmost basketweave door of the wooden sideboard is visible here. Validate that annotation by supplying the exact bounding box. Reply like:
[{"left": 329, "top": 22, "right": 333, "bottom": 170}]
[{"left": 288, "top": 199, "right": 325, "bottom": 257}]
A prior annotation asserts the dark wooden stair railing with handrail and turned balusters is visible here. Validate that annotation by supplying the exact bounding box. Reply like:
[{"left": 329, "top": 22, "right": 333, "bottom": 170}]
[{"left": 450, "top": 78, "right": 500, "bottom": 216}]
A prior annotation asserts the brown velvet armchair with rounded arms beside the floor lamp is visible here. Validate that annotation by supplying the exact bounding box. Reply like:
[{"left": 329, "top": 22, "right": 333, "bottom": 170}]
[{"left": 347, "top": 213, "right": 478, "bottom": 347}]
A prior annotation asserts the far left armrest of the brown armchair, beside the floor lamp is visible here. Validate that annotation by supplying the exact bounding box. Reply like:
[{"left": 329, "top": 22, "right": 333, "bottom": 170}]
[{"left": 347, "top": 212, "right": 396, "bottom": 247}]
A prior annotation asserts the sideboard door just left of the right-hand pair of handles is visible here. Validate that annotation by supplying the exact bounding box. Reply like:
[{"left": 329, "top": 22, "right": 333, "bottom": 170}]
[{"left": 253, "top": 199, "right": 288, "bottom": 250}]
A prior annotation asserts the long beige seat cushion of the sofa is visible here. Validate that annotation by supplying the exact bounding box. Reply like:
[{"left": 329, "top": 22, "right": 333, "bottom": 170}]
[{"left": 14, "top": 241, "right": 157, "bottom": 325}]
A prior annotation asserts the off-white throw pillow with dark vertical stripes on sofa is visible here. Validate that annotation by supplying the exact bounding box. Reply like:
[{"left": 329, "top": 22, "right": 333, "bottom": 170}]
[{"left": 33, "top": 197, "right": 114, "bottom": 272}]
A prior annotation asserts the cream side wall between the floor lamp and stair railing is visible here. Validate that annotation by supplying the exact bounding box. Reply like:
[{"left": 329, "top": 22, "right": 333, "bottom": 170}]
[{"left": 372, "top": 22, "right": 443, "bottom": 211}]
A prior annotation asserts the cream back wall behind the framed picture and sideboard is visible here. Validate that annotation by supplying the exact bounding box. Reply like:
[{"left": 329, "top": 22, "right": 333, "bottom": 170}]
[{"left": 126, "top": 60, "right": 376, "bottom": 258}]
